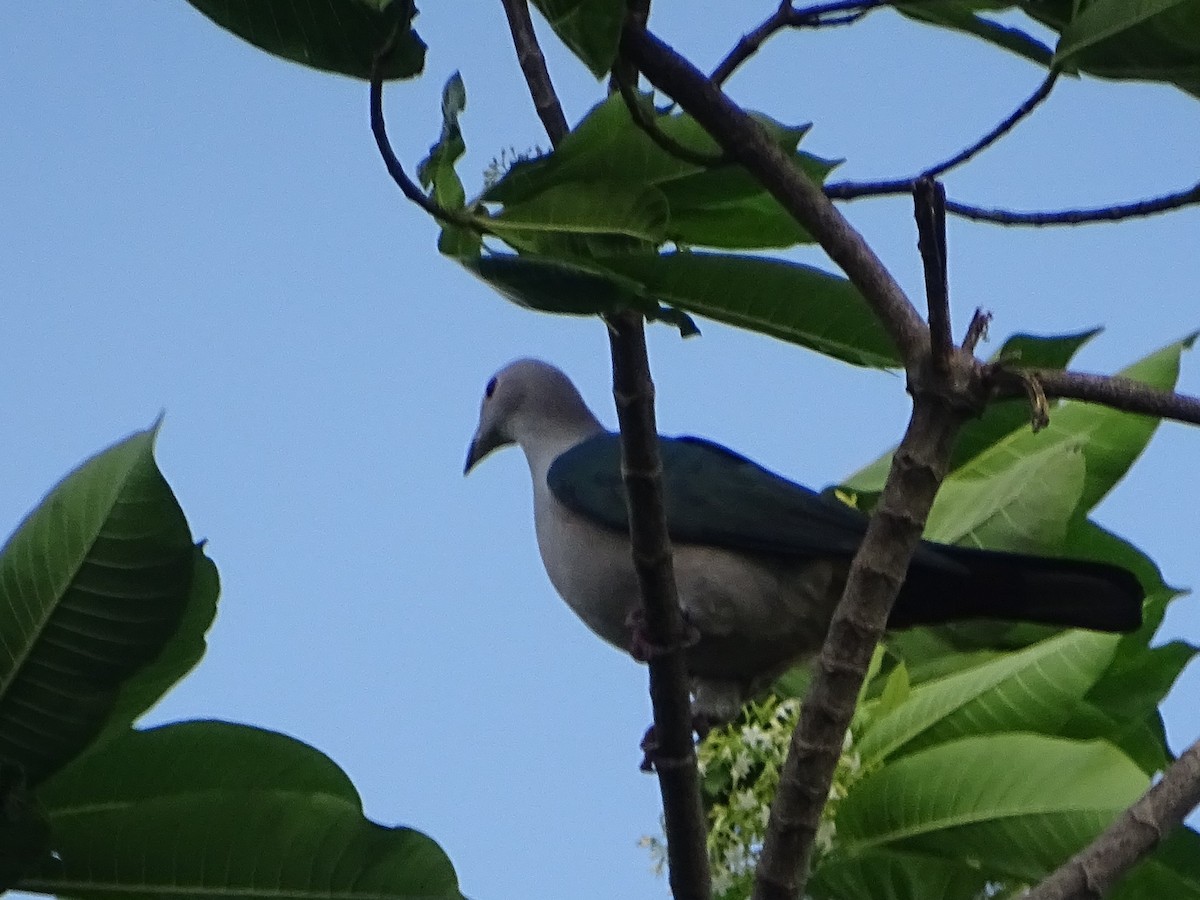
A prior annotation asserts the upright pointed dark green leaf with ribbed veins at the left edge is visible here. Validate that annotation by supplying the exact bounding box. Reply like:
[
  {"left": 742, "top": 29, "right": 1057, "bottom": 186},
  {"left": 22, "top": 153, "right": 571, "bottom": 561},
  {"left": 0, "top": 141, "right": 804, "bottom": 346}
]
[{"left": 0, "top": 430, "right": 193, "bottom": 785}]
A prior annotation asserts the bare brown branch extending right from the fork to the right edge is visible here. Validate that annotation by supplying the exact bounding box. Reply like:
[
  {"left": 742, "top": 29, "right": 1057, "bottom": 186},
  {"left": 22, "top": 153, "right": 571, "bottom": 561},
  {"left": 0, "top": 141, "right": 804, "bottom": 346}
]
[{"left": 986, "top": 365, "right": 1200, "bottom": 425}]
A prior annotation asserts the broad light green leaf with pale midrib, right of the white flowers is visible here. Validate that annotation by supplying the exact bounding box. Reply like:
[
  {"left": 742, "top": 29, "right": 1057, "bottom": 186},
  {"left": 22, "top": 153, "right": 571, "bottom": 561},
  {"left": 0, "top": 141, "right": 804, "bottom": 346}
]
[{"left": 836, "top": 733, "right": 1150, "bottom": 880}]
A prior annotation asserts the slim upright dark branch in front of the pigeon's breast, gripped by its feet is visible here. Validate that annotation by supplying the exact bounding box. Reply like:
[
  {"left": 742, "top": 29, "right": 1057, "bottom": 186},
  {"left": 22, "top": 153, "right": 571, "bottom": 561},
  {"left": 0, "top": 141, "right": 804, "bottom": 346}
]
[{"left": 608, "top": 312, "right": 712, "bottom": 900}]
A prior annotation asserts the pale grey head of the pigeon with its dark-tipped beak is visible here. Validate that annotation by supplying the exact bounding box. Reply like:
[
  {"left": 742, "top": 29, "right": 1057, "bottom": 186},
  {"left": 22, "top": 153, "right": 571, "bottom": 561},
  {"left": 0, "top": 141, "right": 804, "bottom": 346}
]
[{"left": 463, "top": 359, "right": 601, "bottom": 474}]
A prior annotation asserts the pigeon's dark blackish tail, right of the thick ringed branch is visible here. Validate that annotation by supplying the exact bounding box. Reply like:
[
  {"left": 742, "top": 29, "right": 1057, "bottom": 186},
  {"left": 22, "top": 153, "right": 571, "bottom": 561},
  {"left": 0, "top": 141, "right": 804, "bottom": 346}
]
[{"left": 888, "top": 546, "right": 1145, "bottom": 631}]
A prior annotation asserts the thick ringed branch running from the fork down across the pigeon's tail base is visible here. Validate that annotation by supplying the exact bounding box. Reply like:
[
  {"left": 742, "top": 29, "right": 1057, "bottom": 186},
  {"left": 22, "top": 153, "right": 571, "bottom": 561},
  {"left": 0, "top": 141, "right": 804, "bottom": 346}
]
[{"left": 754, "top": 362, "right": 982, "bottom": 900}]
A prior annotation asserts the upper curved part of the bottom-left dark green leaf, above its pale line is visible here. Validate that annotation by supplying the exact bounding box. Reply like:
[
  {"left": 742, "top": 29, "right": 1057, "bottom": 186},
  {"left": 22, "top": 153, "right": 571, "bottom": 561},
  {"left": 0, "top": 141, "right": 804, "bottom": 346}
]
[{"left": 37, "top": 719, "right": 359, "bottom": 816}]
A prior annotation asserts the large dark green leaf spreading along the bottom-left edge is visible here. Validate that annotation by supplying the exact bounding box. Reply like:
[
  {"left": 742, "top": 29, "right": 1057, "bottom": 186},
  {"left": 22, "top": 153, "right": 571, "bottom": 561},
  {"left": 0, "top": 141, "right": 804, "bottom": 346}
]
[{"left": 27, "top": 722, "right": 461, "bottom": 900}]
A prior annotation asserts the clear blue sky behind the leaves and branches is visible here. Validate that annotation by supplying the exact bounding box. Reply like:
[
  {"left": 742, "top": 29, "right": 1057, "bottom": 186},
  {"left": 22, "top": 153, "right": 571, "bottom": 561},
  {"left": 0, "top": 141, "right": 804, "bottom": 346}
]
[{"left": 0, "top": 0, "right": 1200, "bottom": 900}]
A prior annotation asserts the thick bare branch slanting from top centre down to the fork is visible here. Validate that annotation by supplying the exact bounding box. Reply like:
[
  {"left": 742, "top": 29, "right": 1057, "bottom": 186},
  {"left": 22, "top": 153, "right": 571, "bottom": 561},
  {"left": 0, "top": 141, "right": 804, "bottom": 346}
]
[{"left": 620, "top": 25, "right": 929, "bottom": 368}]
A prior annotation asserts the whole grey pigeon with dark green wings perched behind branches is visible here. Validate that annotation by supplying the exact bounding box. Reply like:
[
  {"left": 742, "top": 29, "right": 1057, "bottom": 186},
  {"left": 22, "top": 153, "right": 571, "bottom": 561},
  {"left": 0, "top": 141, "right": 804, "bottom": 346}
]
[{"left": 466, "top": 359, "right": 1142, "bottom": 733}]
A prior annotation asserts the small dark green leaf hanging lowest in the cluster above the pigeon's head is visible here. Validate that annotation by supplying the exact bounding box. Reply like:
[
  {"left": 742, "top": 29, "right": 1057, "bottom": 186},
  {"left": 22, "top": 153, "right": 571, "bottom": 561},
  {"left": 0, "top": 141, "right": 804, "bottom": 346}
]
[{"left": 458, "top": 253, "right": 700, "bottom": 337}]
